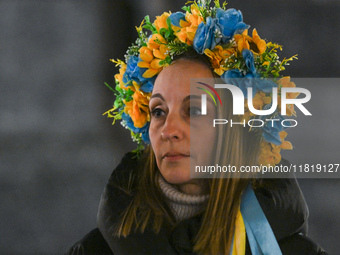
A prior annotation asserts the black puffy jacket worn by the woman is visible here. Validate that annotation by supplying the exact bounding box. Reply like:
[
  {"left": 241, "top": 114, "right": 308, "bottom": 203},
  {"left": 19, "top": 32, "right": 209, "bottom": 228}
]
[{"left": 67, "top": 153, "right": 326, "bottom": 255}]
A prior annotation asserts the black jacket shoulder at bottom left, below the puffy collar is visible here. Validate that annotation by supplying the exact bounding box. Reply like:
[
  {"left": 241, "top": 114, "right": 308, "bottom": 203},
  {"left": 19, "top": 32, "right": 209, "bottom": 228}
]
[{"left": 66, "top": 228, "right": 113, "bottom": 255}]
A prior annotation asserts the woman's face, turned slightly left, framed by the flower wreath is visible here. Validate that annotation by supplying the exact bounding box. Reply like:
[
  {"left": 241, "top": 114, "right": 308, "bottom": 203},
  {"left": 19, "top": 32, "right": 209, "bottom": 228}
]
[{"left": 149, "top": 59, "right": 215, "bottom": 193}]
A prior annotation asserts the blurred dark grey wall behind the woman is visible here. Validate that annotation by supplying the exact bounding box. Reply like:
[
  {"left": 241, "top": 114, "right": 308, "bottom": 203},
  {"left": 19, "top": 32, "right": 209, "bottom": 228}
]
[{"left": 0, "top": 0, "right": 340, "bottom": 254}]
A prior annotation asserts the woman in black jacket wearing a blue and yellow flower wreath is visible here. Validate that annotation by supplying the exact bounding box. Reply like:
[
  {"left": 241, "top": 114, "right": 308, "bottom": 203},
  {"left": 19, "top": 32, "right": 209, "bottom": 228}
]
[{"left": 68, "top": 1, "right": 324, "bottom": 254}]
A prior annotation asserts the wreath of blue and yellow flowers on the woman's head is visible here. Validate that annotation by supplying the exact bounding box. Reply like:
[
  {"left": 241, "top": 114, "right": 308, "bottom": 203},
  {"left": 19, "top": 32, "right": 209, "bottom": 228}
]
[{"left": 104, "top": 0, "right": 298, "bottom": 165}]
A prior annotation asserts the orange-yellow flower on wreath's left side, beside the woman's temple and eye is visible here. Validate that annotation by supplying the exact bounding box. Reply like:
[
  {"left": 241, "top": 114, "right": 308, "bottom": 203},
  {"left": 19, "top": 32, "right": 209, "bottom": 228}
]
[{"left": 124, "top": 81, "right": 151, "bottom": 128}]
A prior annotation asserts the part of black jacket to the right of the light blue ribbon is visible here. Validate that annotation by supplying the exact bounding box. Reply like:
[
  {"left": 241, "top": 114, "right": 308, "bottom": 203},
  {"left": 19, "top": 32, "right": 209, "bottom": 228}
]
[{"left": 254, "top": 159, "right": 326, "bottom": 255}]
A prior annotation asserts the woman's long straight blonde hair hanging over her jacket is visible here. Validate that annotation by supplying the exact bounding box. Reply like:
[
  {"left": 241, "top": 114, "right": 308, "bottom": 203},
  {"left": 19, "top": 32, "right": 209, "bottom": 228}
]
[{"left": 116, "top": 58, "right": 260, "bottom": 255}]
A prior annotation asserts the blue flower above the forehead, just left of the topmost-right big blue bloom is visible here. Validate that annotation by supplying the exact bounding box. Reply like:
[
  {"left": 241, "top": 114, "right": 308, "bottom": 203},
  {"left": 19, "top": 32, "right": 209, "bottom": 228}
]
[{"left": 193, "top": 17, "right": 221, "bottom": 54}]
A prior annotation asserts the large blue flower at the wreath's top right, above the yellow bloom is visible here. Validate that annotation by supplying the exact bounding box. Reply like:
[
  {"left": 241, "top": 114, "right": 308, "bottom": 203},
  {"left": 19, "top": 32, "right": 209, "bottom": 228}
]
[{"left": 216, "top": 8, "right": 249, "bottom": 43}]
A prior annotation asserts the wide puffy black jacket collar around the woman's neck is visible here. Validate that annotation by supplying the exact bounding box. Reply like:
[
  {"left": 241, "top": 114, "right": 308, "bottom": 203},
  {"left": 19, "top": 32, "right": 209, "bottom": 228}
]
[{"left": 97, "top": 153, "right": 308, "bottom": 254}]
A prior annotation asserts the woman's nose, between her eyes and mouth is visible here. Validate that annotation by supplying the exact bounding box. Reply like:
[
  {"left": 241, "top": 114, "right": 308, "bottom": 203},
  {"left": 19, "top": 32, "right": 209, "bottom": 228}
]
[{"left": 161, "top": 113, "right": 186, "bottom": 141}]
